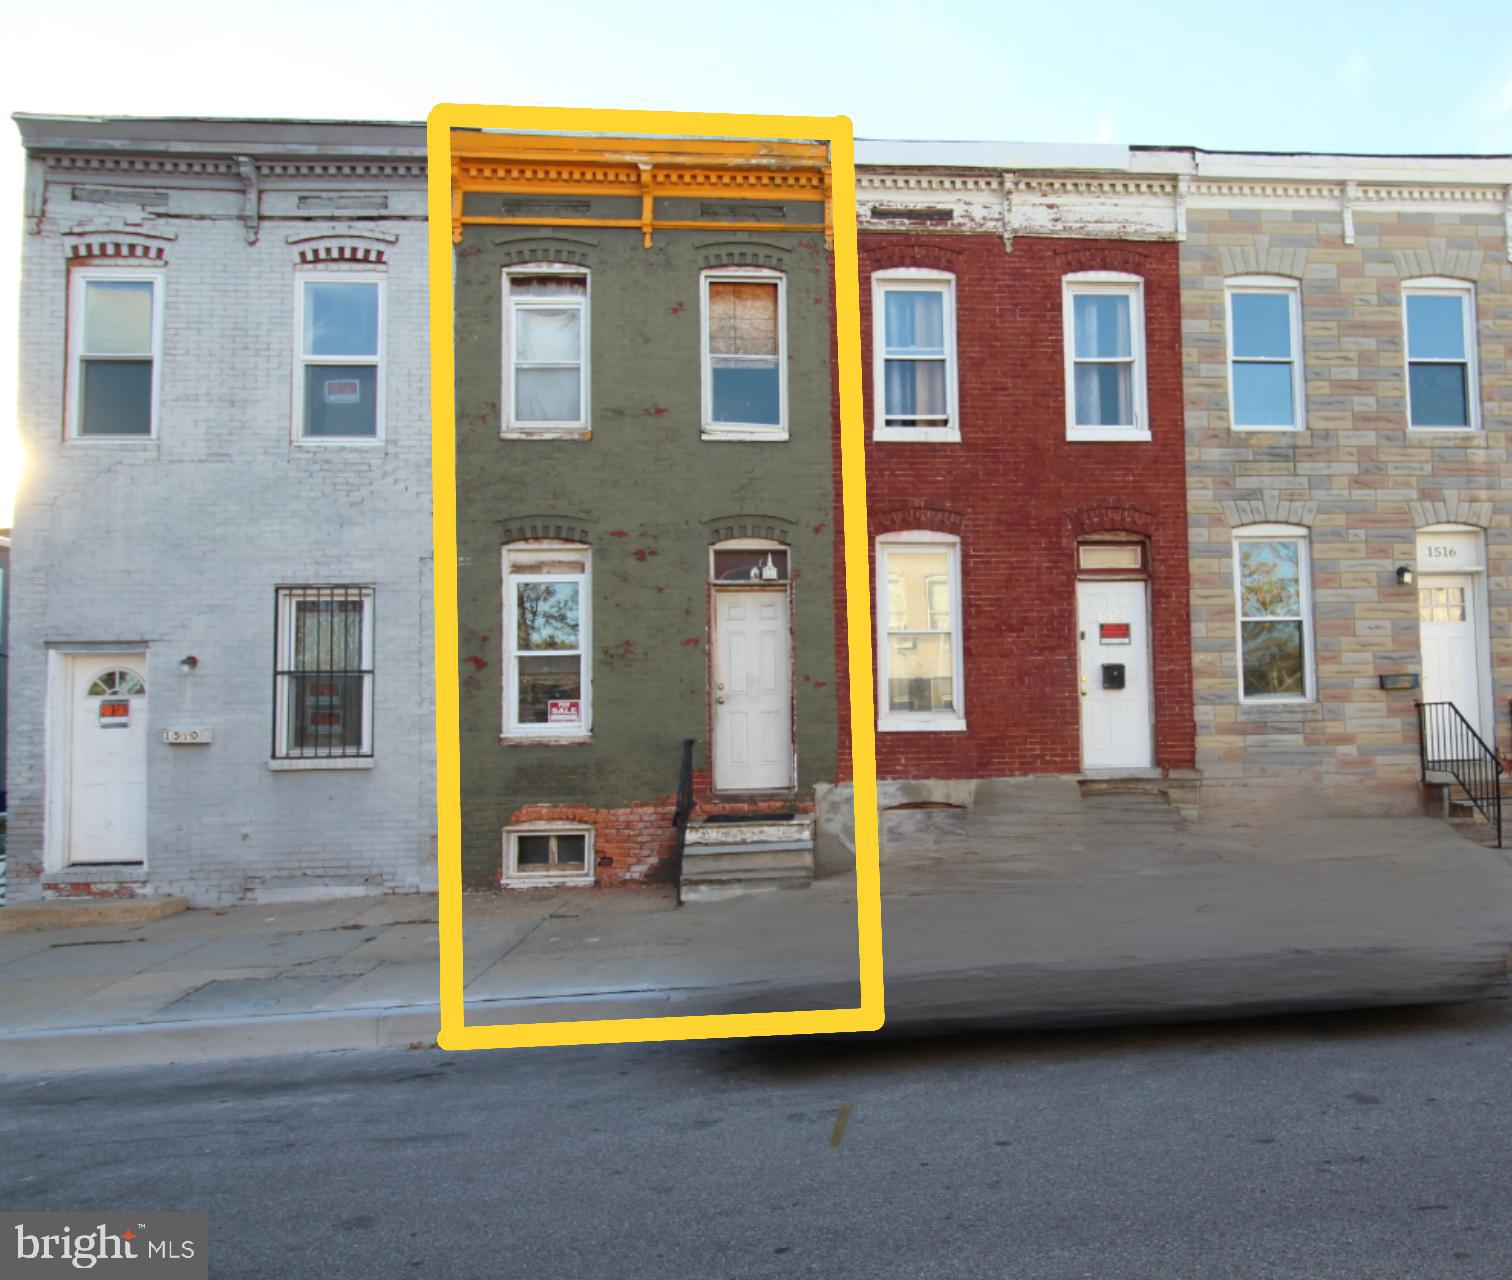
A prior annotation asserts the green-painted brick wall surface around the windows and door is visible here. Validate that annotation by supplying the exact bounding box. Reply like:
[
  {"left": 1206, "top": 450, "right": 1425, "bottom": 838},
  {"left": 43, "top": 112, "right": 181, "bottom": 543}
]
[{"left": 457, "top": 213, "right": 838, "bottom": 886}]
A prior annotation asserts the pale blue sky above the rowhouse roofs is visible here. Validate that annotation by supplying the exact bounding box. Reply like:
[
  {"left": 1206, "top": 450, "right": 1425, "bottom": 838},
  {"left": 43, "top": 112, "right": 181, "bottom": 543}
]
[{"left": 0, "top": 0, "right": 1512, "bottom": 517}]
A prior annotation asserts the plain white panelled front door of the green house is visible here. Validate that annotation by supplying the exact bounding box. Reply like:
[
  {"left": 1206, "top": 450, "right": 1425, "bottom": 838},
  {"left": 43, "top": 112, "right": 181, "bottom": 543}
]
[{"left": 711, "top": 589, "right": 792, "bottom": 790}]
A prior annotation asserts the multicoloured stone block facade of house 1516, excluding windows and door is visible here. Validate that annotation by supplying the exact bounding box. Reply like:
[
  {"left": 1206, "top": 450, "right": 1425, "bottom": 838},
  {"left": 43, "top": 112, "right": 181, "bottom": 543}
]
[{"left": 1181, "top": 167, "right": 1512, "bottom": 810}]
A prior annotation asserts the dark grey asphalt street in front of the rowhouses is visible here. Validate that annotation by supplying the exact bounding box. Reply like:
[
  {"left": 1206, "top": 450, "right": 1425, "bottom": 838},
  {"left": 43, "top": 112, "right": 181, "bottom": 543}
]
[{"left": 0, "top": 1002, "right": 1512, "bottom": 1280}]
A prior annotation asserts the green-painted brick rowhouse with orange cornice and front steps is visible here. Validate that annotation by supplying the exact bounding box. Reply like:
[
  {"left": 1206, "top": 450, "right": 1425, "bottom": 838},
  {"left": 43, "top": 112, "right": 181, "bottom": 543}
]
[{"left": 452, "top": 130, "right": 836, "bottom": 896}]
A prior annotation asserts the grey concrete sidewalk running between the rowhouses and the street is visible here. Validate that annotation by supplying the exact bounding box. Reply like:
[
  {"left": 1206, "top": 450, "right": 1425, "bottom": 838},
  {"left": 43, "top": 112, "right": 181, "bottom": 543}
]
[{"left": 0, "top": 780, "right": 1512, "bottom": 1071}]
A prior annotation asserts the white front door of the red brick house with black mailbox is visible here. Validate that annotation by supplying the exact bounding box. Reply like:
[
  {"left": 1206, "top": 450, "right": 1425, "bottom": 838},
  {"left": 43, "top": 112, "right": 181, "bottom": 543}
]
[{"left": 1077, "top": 582, "right": 1154, "bottom": 769}]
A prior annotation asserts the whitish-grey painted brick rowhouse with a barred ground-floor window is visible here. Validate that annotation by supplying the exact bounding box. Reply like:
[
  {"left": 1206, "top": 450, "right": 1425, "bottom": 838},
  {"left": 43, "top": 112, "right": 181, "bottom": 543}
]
[{"left": 9, "top": 115, "right": 435, "bottom": 904}]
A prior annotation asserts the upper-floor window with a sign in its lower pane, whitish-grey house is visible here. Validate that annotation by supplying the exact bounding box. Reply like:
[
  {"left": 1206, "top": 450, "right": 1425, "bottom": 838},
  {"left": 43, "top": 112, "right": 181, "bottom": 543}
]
[{"left": 295, "top": 272, "right": 384, "bottom": 443}]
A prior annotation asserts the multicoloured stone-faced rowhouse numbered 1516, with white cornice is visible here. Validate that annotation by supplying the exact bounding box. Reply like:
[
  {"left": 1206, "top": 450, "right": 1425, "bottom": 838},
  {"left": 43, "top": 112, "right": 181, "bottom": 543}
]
[{"left": 1181, "top": 145, "right": 1512, "bottom": 812}]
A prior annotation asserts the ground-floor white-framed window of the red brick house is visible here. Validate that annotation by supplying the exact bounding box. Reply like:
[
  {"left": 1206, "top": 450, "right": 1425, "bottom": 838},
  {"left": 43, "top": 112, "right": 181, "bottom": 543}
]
[{"left": 877, "top": 532, "right": 966, "bottom": 730}]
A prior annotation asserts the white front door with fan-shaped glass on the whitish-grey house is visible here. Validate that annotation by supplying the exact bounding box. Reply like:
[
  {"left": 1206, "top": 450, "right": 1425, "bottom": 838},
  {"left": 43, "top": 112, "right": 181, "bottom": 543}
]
[{"left": 67, "top": 653, "right": 147, "bottom": 863}]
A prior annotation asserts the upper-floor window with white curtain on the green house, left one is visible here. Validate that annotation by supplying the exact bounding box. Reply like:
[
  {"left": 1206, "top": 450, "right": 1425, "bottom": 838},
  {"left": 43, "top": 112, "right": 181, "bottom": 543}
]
[{"left": 503, "top": 263, "right": 588, "bottom": 435}]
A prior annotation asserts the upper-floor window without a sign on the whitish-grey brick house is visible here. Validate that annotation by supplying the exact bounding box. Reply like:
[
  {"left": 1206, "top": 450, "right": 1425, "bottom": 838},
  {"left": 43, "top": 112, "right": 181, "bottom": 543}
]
[{"left": 68, "top": 269, "right": 163, "bottom": 440}]
